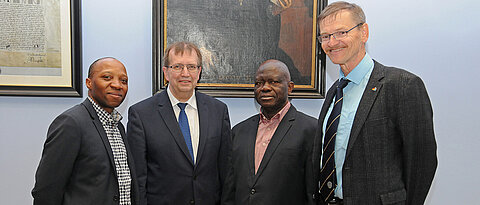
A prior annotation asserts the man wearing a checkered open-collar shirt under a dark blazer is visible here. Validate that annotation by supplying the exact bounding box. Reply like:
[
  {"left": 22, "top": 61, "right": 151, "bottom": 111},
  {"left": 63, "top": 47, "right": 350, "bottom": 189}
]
[{"left": 32, "top": 57, "right": 138, "bottom": 205}]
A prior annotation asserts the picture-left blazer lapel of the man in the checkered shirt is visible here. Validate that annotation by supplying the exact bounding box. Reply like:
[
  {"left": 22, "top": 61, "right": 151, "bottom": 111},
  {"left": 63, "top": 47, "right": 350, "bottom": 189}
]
[{"left": 82, "top": 99, "right": 118, "bottom": 177}]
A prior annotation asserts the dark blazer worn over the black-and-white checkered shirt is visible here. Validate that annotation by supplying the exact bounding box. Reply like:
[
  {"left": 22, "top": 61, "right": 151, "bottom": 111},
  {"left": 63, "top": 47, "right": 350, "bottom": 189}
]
[{"left": 32, "top": 99, "right": 138, "bottom": 205}]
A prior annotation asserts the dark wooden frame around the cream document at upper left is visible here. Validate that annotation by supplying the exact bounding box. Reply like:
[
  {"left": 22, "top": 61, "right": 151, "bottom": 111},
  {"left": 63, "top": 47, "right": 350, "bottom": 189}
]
[{"left": 0, "top": 0, "right": 83, "bottom": 97}]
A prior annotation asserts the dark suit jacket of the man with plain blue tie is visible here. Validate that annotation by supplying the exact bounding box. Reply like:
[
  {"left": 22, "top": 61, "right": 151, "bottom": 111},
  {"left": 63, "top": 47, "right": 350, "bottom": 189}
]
[{"left": 127, "top": 91, "right": 231, "bottom": 205}]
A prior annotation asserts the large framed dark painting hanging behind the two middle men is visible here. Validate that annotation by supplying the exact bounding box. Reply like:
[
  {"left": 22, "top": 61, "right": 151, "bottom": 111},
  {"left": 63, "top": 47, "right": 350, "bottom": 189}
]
[{"left": 153, "top": 0, "right": 326, "bottom": 98}]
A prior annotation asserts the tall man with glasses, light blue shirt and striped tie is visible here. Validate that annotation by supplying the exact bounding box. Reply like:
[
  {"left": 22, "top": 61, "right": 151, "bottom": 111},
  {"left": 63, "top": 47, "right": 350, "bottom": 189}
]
[{"left": 314, "top": 2, "right": 437, "bottom": 205}]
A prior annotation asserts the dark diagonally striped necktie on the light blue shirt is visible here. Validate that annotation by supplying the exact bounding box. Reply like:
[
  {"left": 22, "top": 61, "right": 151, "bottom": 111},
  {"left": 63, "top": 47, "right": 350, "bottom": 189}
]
[{"left": 320, "top": 78, "right": 350, "bottom": 202}]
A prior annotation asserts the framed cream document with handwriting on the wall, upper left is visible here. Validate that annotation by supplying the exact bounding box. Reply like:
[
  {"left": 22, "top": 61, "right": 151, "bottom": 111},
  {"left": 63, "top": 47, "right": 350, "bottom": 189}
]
[{"left": 0, "top": 0, "right": 82, "bottom": 97}]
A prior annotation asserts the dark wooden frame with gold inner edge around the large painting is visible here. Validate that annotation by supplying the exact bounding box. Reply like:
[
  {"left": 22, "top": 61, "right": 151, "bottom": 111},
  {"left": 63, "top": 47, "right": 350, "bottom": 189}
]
[{"left": 152, "top": 0, "right": 327, "bottom": 98}]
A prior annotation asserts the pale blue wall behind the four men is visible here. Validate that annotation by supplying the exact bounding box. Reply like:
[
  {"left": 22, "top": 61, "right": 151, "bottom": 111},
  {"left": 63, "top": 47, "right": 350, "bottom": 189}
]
[{"left": 0, "top": 0, "right": 480, "bottom": 205}]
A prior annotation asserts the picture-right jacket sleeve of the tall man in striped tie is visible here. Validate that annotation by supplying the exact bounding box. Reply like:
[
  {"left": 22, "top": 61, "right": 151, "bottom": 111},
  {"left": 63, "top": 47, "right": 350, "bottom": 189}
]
[{"left": 398, "top": 76, "right": 438, "bottom": 205}]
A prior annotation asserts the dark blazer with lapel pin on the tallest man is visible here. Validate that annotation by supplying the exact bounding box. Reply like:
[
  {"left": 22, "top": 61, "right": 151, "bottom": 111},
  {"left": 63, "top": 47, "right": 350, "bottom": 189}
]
[{"left": 314, "top": 61, "right": 437, "bottom": 205}]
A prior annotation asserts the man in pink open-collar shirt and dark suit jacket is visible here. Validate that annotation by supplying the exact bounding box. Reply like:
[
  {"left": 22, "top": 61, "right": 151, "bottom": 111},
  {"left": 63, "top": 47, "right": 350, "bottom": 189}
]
[{"left": 224, "top": 60, "right": 317, "bottom": 205}]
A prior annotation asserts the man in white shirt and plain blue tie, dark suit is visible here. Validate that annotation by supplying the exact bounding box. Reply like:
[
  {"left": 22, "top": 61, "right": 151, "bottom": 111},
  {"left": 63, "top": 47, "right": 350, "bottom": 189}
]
[{"left": 127, "top": 42, "right": 231, "bottom": 205}]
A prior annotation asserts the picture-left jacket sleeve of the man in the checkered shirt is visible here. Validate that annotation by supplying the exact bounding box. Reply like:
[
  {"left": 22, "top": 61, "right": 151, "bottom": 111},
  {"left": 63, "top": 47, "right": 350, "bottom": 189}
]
[{"left": 32, "top": 114, "right": 82, "bottom": 205}]
